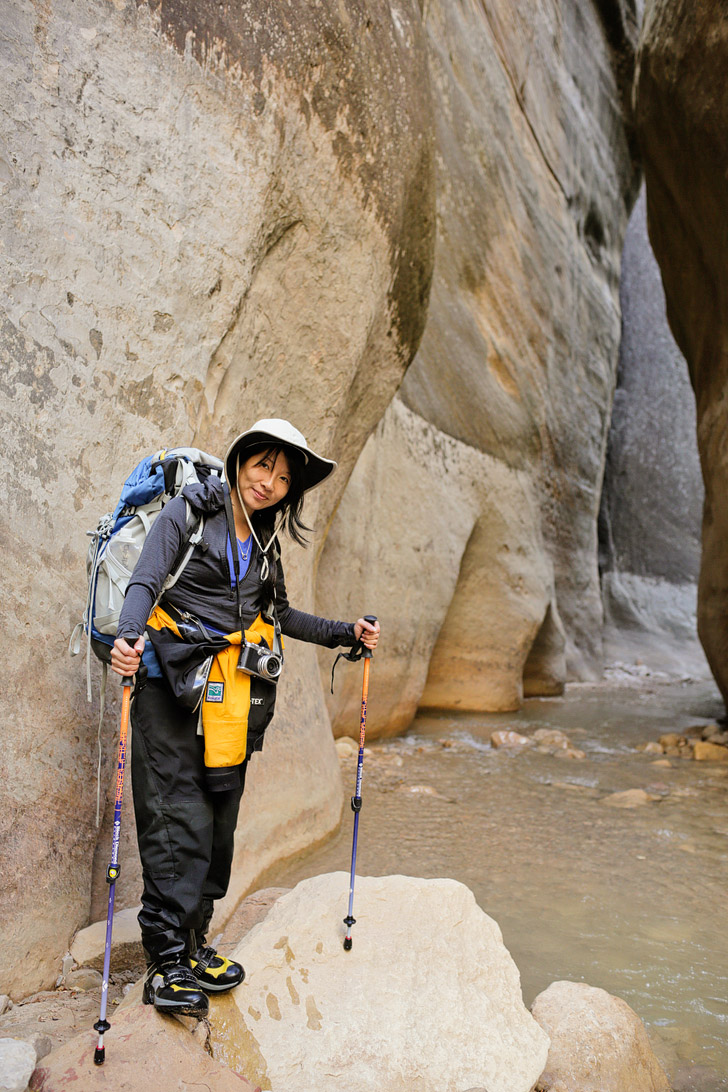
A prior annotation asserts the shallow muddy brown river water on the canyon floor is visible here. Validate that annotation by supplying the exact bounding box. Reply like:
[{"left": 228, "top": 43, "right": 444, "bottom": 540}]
[{"left": 261, "top": 681, "right": 728, "bottom": 1092}]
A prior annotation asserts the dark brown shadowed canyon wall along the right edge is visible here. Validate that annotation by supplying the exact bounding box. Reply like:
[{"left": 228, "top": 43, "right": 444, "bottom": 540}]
[{"left": 635, "top": 0, "right": 728, "bottom": 699}]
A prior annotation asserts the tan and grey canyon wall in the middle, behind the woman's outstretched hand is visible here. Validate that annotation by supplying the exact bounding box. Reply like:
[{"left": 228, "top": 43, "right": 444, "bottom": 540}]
[{"left": 318, "top": 0, "right": 637, "bottom": 735}]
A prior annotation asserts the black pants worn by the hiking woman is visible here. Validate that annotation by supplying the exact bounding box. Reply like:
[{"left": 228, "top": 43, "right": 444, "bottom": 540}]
[{"left": 131, "top": 679, "right": 248, "bottom": 963}]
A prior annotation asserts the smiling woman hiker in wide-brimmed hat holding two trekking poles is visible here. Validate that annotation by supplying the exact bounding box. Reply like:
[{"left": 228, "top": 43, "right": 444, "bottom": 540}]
[{"left": 111, "top": 419, "right": 379, "bottom": 1016}]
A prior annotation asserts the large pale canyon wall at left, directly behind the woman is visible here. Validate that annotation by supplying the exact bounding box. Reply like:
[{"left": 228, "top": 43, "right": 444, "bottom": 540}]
[{"left": 0, "top": 0, "right": 434, "bottom": 997}]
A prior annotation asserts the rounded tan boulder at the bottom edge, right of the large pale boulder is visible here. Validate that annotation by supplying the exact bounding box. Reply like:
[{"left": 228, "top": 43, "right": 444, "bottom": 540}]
[{"left": 532, "top": 982, "right": 670, "bottom": 1092}]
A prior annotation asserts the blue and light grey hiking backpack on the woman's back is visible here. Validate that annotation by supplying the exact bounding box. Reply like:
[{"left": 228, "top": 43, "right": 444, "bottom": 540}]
[{"left": 69, "top": 448, "right": 223, "bottom": 701}]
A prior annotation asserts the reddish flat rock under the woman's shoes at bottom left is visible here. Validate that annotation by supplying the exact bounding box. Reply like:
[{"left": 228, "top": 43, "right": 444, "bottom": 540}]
[{"left": 29, "top": 998, "right": 254, "bottom": 1092}]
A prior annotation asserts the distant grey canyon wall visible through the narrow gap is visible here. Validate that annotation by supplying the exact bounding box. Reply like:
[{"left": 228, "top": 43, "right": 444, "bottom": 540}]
[{"left": 599, "top": 192, "right": 707, "bottom": 674}]
